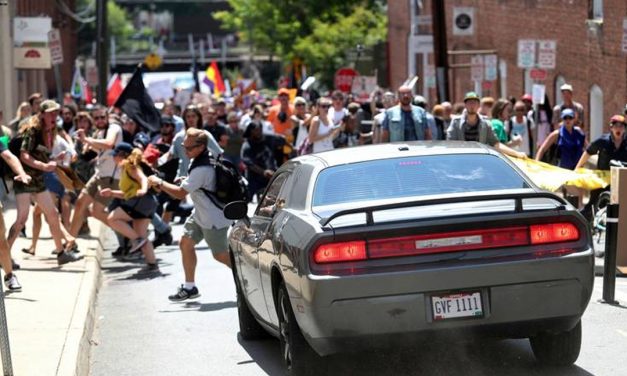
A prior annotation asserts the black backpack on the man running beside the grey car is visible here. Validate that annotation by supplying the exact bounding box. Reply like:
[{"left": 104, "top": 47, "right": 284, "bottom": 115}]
[{"left": 188, "top": 152, "right": 248, "bottom": 209}]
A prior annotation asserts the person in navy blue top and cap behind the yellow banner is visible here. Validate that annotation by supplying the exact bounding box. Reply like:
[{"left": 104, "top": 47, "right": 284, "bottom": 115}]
[{"left": 536, "top": 108, "right": 587, "bottom": 170}]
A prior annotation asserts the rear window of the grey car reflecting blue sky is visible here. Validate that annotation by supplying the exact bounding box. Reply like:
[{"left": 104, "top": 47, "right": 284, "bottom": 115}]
[{"left": 313, "top": 154, "right": 529, "bottom": 206}]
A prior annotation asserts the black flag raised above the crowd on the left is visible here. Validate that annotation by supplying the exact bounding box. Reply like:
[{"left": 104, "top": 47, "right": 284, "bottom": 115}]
[{"left": 114, "top": 67, "right": 161, "bottom": 132}]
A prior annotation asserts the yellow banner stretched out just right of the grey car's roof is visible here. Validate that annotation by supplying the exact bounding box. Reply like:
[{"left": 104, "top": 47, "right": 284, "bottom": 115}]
[{"left": 509, "top": 157, "right": 610, "bottom": 192}]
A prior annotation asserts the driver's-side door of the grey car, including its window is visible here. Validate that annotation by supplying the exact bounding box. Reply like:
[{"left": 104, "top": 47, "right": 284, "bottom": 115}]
[{"left": 240, "top": 172, "right": 288, "bottom": 321}]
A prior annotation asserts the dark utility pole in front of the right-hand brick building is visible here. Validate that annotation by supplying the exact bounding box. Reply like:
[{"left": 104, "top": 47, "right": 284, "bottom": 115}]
[{"left": 431, "top": 0, "right": 449, "bottom": 103}]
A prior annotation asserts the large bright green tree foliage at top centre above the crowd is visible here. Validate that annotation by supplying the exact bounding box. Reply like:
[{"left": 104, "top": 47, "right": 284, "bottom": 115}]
[{"left": 214, "top": 0, "right": 387, "bottom": 83}]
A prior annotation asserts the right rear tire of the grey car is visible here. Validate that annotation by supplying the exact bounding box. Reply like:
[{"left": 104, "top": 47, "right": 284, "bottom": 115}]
[{"left": 529, "top": 320, "right": 581, "bottom": 366}]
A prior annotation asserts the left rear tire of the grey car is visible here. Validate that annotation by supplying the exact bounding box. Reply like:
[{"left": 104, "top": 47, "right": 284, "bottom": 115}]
[{"left": 277, "top": 282, "right": 324, "bottom": 376}]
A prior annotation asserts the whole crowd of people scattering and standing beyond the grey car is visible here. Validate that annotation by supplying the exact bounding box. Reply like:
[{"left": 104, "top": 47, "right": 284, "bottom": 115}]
[{"left": 0, "top": 84, "right": 627, "bottom": 301}]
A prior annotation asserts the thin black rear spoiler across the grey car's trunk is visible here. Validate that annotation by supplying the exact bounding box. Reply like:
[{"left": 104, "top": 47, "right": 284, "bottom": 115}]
[{"left": 320, "top": 189, "right": 568, "bottom": 226}]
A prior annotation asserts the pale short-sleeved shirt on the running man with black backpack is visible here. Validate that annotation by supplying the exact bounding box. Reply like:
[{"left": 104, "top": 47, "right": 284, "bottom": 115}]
[{"left": 181, "top": 166, "right": 231, "bottom": 229}]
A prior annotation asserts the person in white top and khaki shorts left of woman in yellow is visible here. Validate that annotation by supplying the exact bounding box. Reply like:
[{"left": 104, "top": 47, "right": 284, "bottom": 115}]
[{"left": 70, "top": 105, "right": 123, "bottom": 247}]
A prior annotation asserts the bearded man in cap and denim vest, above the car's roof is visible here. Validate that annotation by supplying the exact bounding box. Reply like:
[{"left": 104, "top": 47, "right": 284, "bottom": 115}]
[{"left": 381, "top": 86, "right": 432, "bottom": 142}]
